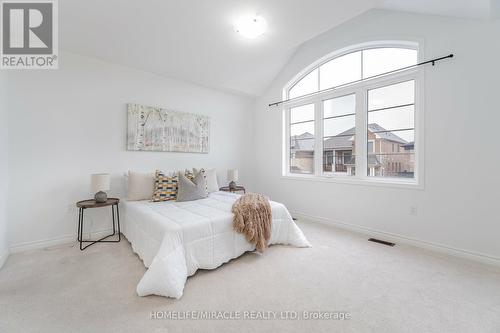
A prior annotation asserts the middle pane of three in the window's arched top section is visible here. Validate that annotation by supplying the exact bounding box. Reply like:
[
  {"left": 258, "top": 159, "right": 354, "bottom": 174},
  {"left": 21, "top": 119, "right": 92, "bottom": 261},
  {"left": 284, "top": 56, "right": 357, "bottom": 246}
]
[{"left": 319, "top": 51, "right": 361, "bottom": 90}]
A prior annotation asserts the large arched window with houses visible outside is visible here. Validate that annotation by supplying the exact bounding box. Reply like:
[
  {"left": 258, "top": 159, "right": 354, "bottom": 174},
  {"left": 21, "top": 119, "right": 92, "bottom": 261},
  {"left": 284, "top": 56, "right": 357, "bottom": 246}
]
[{"left": 283, "top": 42, "right": 420, "bottom": 183}]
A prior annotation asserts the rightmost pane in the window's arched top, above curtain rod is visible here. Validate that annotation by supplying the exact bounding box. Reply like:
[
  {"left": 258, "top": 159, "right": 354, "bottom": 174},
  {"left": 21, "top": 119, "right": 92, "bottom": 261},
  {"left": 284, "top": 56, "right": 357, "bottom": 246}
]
[{"left": 363, "top": 48, "right": 417, "bottom": 78}]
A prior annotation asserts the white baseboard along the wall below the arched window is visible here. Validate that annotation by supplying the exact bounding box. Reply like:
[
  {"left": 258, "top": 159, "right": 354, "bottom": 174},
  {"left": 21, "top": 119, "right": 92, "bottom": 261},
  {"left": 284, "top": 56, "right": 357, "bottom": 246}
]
[{"left": 290, "top": 212, "right": 500, "bottom": 266}]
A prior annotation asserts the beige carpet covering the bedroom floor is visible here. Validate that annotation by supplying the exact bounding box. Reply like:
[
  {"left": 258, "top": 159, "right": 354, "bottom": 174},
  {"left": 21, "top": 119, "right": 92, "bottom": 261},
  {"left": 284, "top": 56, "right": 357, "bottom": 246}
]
[{"left": 0, "top": 222, "right": 500, "bottom": 333}]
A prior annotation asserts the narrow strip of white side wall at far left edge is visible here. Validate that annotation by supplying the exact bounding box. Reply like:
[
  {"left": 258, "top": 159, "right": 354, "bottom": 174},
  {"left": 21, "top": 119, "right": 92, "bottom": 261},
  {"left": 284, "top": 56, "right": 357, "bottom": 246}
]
[{"left": 0, "top": 71, "right": 9, "bottom": 267}]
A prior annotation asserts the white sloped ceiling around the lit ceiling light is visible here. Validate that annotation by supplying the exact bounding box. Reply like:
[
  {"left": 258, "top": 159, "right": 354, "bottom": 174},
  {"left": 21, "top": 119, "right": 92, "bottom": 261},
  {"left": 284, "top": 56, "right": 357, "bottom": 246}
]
[{"left": 59, "top": 0, "right": 496, "bottom": 96}]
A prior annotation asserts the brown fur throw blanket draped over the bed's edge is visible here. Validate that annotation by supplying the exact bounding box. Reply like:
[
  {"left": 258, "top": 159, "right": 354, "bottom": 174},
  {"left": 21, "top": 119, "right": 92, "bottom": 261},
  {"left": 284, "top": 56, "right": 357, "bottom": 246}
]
[{"left": 231, "top": 193, "right": 272, "bottom": 253}]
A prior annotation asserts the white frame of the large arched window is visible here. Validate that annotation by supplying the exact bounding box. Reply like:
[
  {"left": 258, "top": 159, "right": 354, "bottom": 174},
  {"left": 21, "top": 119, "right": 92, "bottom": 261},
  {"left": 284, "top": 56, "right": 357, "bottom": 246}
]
[{"left": 282, "top": 41, "right": 424, "bottom": 189}]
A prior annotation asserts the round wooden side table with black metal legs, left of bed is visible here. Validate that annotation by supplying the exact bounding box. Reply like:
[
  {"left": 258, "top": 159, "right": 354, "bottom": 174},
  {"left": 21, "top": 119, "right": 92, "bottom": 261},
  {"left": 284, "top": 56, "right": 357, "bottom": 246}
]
[{"left": 76, "top": 198, "right": 121, "bottom": 251}]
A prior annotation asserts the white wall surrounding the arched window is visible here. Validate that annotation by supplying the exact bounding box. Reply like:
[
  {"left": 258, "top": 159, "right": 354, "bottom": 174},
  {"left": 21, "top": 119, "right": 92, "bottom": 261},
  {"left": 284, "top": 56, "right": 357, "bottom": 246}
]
[{"left": 254, "top": 11, "right": 500, "bottom": 258}]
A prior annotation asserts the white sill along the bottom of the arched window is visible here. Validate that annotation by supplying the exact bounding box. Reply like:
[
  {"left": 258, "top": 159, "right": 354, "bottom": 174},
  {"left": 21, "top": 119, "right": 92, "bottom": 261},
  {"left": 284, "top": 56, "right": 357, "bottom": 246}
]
[{"left": 281, "top": 174, "right": 424, "bottom": 190}]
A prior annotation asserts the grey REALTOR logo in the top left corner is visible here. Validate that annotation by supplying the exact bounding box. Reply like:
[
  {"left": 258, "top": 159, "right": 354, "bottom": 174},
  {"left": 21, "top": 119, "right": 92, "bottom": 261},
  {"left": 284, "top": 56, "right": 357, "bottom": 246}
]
[{"left": 0, "top": 0, "right": 58, "bottom": 69}]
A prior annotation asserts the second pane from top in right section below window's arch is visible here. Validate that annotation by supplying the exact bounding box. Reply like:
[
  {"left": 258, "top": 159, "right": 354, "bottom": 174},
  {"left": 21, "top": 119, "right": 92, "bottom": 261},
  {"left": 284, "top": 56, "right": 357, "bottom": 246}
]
[{"left": 368, "top": 105, "right": 415, "bottom": 130}]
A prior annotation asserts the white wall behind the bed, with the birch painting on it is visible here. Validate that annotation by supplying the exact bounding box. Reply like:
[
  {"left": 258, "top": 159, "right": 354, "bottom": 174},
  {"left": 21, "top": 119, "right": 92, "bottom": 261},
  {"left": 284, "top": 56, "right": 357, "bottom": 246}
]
[{"left": 8, "top": 52, "right": 252, "bottom": 250}]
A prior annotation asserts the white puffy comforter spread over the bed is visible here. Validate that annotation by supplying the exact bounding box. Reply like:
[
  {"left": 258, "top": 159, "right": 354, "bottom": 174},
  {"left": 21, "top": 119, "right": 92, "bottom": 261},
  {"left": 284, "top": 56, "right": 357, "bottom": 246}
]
[{"left": 122, "top": 192, "right": 310, "bottom": 298}]
